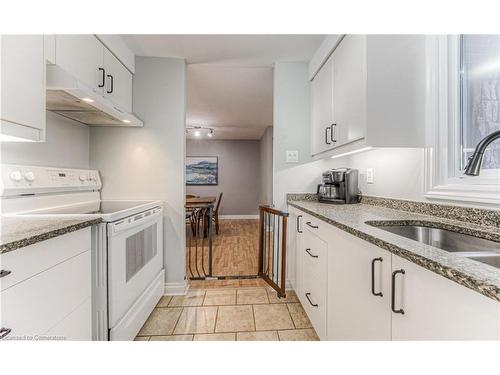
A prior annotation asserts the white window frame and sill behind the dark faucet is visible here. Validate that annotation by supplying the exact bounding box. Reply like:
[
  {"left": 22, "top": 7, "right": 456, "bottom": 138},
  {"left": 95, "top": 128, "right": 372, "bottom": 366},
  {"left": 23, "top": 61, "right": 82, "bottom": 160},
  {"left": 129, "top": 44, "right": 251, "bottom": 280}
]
[{"left": 425, "top": 35, "right": 500, "bottom": 208}]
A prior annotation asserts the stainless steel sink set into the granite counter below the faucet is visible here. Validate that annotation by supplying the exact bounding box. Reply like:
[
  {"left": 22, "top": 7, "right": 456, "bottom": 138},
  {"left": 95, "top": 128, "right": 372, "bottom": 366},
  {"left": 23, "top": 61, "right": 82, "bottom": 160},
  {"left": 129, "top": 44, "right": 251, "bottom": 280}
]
[{"left": 367, "top": 222, "right": 500, "bottom": 268}]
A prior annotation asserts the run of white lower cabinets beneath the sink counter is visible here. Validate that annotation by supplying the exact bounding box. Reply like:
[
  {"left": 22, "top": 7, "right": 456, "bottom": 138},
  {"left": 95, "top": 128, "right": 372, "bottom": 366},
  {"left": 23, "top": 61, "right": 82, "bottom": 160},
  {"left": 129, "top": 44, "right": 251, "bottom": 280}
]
[{"left": 289, "top": 208, "right": 500, "bottom": 340}]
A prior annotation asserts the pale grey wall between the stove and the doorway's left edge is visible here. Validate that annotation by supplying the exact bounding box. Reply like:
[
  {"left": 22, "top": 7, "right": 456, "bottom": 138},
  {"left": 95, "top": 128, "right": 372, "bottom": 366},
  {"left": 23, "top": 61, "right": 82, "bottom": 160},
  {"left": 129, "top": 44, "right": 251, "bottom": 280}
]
[{"left": 90, "top": 57, "right": 186, "bottom": 285}]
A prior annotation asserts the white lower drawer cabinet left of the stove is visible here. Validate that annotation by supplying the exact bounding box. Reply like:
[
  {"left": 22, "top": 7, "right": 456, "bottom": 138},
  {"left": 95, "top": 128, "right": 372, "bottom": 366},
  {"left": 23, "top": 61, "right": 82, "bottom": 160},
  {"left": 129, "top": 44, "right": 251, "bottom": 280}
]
[{"left": 0, "top": 228, "right": 92, "bottom": 340}]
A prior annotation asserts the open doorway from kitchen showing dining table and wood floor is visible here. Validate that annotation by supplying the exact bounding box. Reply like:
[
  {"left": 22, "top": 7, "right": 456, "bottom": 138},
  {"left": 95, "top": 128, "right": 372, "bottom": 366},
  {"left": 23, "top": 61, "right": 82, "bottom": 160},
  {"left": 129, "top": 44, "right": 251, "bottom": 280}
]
[{"left": 185, "top": 64, "right": 273, "bottom": 280}]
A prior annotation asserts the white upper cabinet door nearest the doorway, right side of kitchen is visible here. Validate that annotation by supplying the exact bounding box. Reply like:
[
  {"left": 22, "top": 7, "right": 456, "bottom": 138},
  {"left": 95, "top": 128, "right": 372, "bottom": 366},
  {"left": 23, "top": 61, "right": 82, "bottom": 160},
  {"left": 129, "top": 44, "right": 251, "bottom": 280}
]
[{"left": 311, "top": 57, "right": 333, "bottom": 155}]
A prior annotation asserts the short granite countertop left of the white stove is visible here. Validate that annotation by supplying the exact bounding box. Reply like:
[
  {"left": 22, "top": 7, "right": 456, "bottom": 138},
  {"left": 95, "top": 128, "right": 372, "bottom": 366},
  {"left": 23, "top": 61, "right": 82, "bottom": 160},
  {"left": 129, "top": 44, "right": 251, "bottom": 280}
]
[{"left": 0, "top": 215, "right": 101, "bottom": 254}]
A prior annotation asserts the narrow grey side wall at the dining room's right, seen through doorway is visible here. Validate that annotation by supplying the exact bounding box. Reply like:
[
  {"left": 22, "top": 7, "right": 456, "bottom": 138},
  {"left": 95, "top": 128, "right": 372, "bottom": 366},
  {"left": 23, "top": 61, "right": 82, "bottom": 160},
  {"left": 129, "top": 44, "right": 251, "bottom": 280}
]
[{"left": 260, "top": 126, "right": 273, "bottom": 205}]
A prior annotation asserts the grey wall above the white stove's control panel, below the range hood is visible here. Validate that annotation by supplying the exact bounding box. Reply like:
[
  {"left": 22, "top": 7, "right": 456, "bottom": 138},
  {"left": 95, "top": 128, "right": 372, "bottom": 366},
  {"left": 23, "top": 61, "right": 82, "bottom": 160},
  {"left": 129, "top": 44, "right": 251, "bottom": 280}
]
[{"left": 1, "top": 111, "right": 89, "bottom": 168}]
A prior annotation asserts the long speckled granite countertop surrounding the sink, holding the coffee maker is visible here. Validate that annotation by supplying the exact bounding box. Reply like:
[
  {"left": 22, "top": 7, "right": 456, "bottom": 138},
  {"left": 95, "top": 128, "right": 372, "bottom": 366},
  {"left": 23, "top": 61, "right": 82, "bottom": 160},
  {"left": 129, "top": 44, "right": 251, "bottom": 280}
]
[{"left": 288, "top": 197, "right": 500, "bottom": 302}]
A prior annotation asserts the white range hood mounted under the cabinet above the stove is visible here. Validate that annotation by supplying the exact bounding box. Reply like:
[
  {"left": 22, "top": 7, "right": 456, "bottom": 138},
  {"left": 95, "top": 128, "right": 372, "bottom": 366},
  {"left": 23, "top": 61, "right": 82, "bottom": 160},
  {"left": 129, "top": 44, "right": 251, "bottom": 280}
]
[{"left": 46, "top": 65, "right": 144, "bottom": 127}]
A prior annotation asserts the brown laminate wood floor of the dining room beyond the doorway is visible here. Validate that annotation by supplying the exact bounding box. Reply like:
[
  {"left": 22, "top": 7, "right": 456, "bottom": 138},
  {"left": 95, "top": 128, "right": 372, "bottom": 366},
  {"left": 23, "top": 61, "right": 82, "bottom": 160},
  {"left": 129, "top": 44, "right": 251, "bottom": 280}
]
[{"left": 186, "top": 220, "right": 259, "bottom": 278}]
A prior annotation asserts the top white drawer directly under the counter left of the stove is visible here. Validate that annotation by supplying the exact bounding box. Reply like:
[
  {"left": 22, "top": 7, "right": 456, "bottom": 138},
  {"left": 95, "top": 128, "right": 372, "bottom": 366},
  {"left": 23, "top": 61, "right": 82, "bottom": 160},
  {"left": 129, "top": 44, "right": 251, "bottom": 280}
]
[{"left": 0, "top": 227, "right": 91, "bottom": 291}]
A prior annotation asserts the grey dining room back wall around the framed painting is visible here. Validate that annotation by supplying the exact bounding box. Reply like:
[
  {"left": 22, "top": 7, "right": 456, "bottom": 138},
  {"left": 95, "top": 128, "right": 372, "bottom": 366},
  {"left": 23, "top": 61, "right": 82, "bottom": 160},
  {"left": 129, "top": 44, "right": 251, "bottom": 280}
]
[{"left": 186, "top": 140, "right": 261, "bottom": 215}]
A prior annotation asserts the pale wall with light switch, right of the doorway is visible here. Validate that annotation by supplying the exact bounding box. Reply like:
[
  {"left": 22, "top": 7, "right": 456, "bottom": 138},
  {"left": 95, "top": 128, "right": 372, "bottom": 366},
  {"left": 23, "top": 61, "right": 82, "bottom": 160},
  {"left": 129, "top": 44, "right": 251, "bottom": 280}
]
[{"left": 273, "top": 63, "right": 321, "bottom": 210}]
